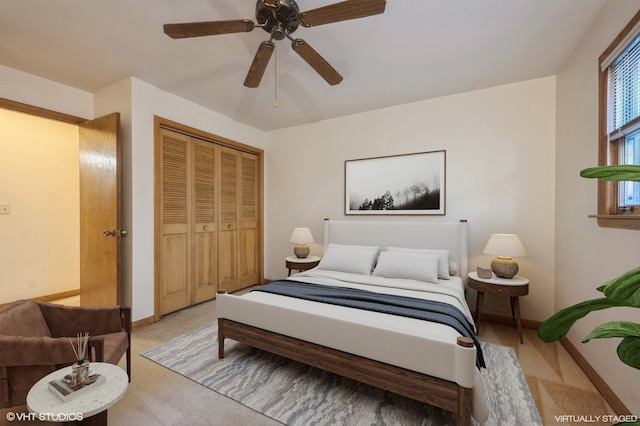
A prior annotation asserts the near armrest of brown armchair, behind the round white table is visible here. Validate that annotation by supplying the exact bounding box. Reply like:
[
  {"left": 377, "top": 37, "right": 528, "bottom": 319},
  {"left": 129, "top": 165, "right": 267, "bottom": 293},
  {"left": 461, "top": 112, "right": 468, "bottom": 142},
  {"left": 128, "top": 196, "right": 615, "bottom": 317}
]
[{"left": 0, "top": 336, "right": 76, "bottom": 367}]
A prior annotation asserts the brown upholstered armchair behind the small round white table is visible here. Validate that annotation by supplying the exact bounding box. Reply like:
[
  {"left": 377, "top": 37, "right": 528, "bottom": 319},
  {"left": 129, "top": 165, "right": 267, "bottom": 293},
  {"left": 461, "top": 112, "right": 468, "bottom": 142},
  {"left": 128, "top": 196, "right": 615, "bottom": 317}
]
[{"left": 0, "top": 300, "right": 131, "bottom": 408}]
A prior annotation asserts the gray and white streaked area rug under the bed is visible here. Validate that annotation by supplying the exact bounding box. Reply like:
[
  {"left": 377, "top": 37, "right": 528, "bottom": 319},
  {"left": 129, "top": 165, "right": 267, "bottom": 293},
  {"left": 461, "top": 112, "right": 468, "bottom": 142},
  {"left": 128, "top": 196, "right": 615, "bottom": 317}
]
[{"left": 141, "top": 322, "right": 542, "bottom": 426}]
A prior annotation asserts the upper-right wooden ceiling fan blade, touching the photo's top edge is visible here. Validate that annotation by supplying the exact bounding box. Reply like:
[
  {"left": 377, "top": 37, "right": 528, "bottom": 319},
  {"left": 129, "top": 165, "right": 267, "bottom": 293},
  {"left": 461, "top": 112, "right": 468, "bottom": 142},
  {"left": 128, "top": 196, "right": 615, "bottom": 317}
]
[{"left": 300, "top": 0, "right": 387, "bottom": 27}]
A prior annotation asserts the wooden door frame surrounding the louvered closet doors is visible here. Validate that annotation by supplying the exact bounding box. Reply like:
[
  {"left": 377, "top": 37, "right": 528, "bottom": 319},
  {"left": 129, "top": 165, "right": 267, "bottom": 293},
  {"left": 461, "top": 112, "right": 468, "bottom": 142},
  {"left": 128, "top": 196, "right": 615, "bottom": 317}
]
[{"left": 153, "top": 115, "right": 264, "bottom": 322}]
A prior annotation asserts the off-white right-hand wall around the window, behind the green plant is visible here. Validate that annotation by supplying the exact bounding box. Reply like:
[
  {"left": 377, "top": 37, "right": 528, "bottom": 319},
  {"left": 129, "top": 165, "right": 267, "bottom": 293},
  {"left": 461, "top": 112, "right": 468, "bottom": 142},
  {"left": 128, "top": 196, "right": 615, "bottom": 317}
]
[{"left": 555, "top": 0, "right": 640, "bottom": 414}]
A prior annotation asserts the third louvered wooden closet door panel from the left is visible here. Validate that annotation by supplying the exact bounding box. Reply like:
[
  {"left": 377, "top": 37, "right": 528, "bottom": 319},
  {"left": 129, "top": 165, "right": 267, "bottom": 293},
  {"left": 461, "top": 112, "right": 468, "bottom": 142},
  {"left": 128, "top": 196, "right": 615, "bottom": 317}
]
[{"left": 218, "top": 147, "right": 240, "bottom": 292}]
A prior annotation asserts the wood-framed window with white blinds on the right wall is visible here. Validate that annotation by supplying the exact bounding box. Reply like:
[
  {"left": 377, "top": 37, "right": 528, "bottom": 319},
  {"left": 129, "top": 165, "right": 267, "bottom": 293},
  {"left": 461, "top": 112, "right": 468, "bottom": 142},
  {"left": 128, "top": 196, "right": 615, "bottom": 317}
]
[{"left": 597, "top": 12, "right": 640, "bottom": 229}]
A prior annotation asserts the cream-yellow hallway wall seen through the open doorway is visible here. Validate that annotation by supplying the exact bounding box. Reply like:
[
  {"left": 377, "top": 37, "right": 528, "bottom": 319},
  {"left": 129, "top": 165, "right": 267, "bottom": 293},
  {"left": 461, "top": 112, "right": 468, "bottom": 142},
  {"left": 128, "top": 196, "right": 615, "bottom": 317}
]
[{"left": 0, "top": 109, "right": 80, "bottom": 303}]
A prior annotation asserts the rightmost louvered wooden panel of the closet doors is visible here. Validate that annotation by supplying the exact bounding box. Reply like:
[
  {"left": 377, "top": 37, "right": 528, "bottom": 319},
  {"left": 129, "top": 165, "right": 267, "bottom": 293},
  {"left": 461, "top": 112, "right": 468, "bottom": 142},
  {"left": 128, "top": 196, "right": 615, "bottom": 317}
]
[{"left": 238, "top": 153, "right": 260, "bottom": 288}]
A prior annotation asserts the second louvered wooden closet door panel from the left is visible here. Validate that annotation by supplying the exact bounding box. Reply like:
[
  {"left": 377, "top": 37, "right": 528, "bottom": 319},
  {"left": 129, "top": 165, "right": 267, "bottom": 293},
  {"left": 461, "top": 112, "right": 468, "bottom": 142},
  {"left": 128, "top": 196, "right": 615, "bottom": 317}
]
[{"left": 192, "top": 139, "right": 218, "bottom": 303}]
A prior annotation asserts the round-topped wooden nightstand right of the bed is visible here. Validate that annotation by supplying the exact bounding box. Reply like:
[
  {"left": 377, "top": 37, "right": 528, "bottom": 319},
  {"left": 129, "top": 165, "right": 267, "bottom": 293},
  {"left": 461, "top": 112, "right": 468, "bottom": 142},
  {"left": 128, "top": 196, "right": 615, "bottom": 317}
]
[{"left": 468, "top": 272, "right": 529, "bottom": 344}]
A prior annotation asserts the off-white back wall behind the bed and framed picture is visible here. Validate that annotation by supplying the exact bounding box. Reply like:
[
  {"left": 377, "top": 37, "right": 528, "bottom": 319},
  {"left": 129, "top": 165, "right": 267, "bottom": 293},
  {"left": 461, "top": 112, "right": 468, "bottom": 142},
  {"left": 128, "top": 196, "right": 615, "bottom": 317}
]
[{"left": 265, "top": 77, "right": 555, "bottom": 321}]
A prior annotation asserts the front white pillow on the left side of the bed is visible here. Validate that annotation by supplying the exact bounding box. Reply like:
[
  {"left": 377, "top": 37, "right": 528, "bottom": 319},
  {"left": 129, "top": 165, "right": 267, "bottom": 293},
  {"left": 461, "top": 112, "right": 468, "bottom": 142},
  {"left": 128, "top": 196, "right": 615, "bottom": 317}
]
[{"left": 317, "top": 244, "right": 378, "bottom": 275}]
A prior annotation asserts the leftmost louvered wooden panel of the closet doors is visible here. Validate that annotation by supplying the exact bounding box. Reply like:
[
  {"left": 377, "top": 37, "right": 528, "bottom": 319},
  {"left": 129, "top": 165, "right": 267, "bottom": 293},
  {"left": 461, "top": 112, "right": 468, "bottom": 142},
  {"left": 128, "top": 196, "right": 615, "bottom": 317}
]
[{"left": 159, "top": 130, "right": 191, "bottom": 315}]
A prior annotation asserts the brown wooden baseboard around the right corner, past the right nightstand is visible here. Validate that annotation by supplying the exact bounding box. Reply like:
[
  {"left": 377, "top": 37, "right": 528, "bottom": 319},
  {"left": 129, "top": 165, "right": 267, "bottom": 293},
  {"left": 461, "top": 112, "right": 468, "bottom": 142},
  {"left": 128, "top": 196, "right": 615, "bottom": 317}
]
[{"left": 482, "top": 314, "right": 632, "bottom": 415}]
